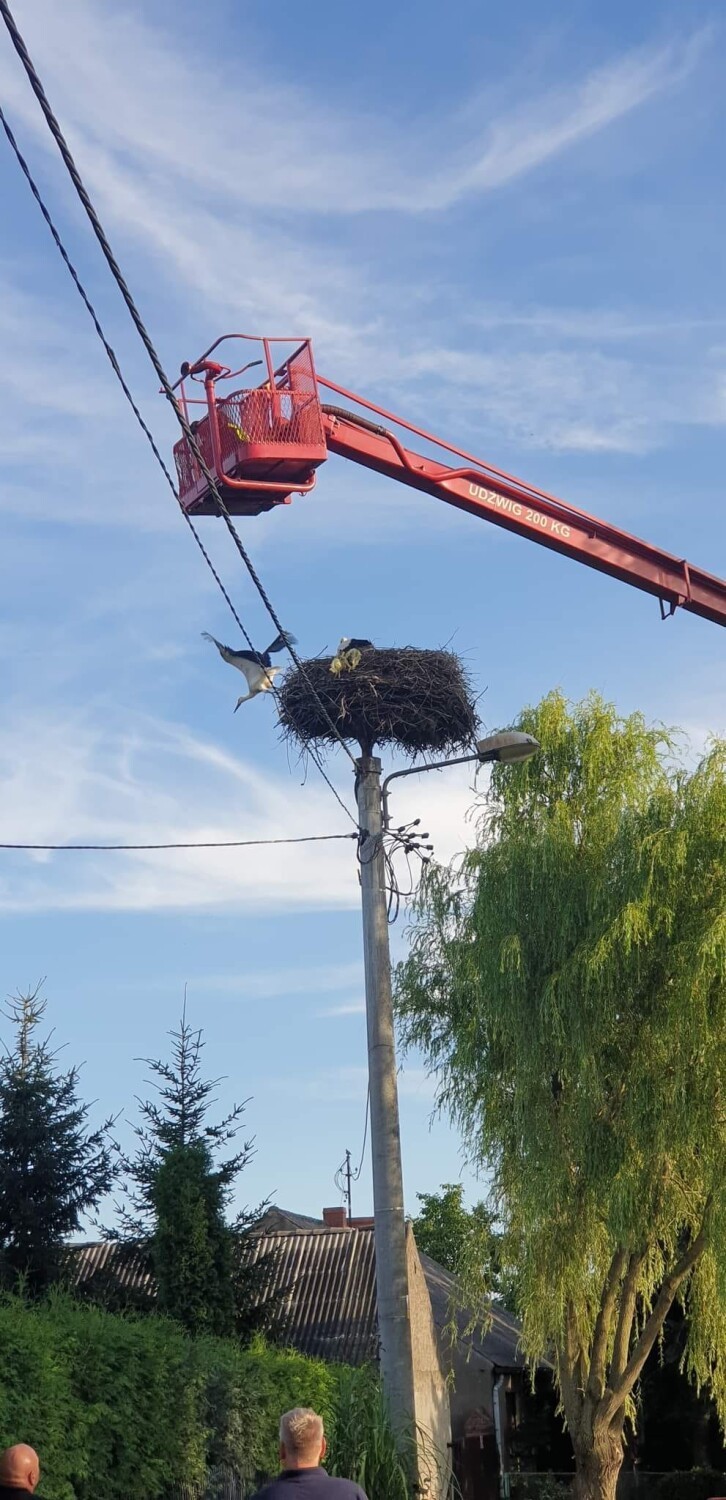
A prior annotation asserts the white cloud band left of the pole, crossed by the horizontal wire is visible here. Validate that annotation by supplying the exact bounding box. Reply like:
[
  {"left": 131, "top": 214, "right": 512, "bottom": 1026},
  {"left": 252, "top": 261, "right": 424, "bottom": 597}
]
[{"left": 0, "top": 714, "right": 359, "bottom": 912}]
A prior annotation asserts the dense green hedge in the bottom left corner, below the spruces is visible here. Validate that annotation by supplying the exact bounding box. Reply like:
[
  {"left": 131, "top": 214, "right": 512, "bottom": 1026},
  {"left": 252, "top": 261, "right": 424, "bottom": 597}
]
[{"left": 0, "top": 1296, "right": 206, "bottom": 1500}]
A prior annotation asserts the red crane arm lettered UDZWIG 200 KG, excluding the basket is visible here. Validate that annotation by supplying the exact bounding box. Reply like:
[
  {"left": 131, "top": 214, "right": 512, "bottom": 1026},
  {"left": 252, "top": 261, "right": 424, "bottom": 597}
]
[{"left": 318, "top": 393, "right": 726, "bottom": 626}]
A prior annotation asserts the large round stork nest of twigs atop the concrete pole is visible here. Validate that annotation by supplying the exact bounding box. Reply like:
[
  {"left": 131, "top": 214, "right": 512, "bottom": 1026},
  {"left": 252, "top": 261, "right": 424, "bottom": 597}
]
[{"left": 278, "top": 647, "right": 477, "bottom": 756}]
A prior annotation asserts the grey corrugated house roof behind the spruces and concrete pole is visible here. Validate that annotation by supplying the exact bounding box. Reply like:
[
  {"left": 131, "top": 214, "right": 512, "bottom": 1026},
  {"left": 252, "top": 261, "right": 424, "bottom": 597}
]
[{"left": 74, "top": 1208, "right": 525, "bottom": 1370}]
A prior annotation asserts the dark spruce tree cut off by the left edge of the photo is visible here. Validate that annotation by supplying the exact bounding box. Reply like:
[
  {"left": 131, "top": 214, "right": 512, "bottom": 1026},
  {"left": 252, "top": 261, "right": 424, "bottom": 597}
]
[{"left": 0, "top": 990, "right": 114, "bottom": 1296}]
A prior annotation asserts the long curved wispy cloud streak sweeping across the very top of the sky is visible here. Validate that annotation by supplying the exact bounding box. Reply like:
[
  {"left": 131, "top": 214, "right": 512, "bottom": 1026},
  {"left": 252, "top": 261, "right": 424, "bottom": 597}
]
[{"left": 2, "top": 0, "right": 708, "bottom": 215}]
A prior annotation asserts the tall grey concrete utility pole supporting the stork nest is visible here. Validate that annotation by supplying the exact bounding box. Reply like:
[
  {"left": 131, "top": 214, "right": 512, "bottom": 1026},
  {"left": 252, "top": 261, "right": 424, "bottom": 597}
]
[{"left": 357, "top": 756, "right": 416, "bottom": 1434}]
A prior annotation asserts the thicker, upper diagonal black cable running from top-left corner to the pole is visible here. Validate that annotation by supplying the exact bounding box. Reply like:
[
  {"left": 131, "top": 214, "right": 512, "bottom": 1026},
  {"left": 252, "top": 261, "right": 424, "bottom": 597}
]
[{"left": 0, "top": 0, "right": 356, "bottom": 798}]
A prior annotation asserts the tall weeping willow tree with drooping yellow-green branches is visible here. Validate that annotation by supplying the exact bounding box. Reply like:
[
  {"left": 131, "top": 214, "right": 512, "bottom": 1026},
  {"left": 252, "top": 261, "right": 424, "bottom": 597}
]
[{"left": 398, "top": 693, "right": 726, "bottom": 1500}]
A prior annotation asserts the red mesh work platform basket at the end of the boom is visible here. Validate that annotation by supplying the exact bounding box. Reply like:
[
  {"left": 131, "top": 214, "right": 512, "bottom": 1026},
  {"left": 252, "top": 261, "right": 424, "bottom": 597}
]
[{"left": 174, "top": 333, "right": 327, "bottom": 516}]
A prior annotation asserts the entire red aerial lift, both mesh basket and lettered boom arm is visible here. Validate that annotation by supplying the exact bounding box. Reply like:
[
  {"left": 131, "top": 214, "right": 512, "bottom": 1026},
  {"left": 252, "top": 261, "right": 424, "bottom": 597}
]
[{"left": 174, "top": 335, "right": 726, "bottom": 626}]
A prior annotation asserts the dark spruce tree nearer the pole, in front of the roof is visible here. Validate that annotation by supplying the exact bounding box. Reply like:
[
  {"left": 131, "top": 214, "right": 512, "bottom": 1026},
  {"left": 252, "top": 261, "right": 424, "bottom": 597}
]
[{"left": 120, "top": 1010, "right": 263, "bottom": 1337}]
